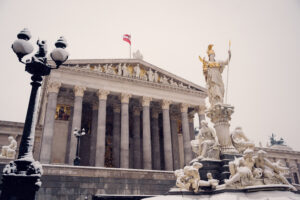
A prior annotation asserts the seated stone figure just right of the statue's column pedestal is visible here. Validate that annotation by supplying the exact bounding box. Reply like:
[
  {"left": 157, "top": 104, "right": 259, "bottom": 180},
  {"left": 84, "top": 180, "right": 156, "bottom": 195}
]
[{"left": 231, "top": 127, "right": 254, "bottom": 153}]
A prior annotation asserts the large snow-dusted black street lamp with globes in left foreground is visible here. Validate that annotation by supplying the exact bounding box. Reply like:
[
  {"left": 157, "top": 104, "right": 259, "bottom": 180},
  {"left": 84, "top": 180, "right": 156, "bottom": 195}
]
[{"left": 0, "top": 28, "right": 68, "bottom": 200}]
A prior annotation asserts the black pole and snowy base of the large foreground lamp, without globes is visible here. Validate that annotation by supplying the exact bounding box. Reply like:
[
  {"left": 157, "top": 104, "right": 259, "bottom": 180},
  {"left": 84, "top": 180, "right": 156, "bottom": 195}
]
[{"left": 0, "top": 75, "right": 42, "bottom": 200}]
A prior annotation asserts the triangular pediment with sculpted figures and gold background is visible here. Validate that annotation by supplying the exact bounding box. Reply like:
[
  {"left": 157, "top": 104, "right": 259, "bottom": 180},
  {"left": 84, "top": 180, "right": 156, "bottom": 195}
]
[{"left": 59, "top": 59, "right": 206, "bottom": 92}]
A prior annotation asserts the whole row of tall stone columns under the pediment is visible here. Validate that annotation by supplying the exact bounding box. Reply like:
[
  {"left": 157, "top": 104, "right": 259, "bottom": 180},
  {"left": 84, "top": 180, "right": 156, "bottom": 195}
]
[{"left": 40, "top": 82, "right": 206, "bottom": 170}]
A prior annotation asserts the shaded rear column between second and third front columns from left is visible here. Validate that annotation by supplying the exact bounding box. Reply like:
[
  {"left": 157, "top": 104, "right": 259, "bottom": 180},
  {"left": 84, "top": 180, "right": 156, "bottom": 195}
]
[{"left": 90, "top": 102, "right": 99, "bottom": 166}]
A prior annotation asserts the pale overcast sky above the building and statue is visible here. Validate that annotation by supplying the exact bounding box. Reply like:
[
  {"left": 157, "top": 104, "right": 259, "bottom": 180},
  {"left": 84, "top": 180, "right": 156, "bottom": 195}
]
[{"left": 0, "top": 0, "right": 300, "bottom": 150}]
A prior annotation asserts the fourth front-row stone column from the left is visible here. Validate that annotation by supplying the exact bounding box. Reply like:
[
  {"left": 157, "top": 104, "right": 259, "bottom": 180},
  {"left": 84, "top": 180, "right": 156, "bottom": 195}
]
[{"left": 120, "top": 94, "right": 131, "bottom": 168}]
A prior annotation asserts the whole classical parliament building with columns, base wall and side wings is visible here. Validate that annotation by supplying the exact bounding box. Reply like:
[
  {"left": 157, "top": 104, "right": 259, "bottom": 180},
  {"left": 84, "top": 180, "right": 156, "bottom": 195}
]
[{"left": 0, "top": 59, "right": 300, "bottom": 199}]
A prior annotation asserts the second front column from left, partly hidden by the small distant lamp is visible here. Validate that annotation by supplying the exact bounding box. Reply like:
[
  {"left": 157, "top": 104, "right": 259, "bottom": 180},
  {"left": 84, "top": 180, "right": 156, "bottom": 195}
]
[{"left": 69, "top": 86, "right": 86, "bottom": 165}]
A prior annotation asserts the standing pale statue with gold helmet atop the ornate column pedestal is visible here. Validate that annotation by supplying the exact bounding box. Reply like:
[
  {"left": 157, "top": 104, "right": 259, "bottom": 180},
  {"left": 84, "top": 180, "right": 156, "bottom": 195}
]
[{"left": 199, "top": 44, "right": 231, "bottom": 107}]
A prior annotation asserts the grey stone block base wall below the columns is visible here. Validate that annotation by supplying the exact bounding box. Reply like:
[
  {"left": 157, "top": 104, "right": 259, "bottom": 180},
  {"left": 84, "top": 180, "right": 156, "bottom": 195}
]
[{"left": 0, "top": 163, "right": 175, "bottom": 200}]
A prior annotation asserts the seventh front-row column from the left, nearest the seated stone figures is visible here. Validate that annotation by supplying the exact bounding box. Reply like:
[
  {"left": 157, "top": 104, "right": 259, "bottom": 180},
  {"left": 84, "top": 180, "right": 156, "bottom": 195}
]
[{"left": 180, "top": 104, "right": 192, "bottom": 165}]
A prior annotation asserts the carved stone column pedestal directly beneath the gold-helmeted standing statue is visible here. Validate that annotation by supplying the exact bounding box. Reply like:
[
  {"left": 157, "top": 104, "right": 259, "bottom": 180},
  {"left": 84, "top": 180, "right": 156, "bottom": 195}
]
[{"left": 207, "top": 104, "right": 238, "bottom": 154}]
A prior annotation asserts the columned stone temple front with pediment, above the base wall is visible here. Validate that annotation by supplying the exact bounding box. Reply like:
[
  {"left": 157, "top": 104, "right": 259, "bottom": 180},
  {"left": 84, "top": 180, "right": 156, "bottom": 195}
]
[{"left": 37, "top": 59, "right": 207, "bottom": 170}]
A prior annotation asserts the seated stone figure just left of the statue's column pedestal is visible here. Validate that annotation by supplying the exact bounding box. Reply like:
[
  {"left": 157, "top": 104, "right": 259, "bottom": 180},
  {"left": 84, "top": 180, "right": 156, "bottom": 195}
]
[{"left": 191, "top": 120, "right": 220, "bottom": 162}]
